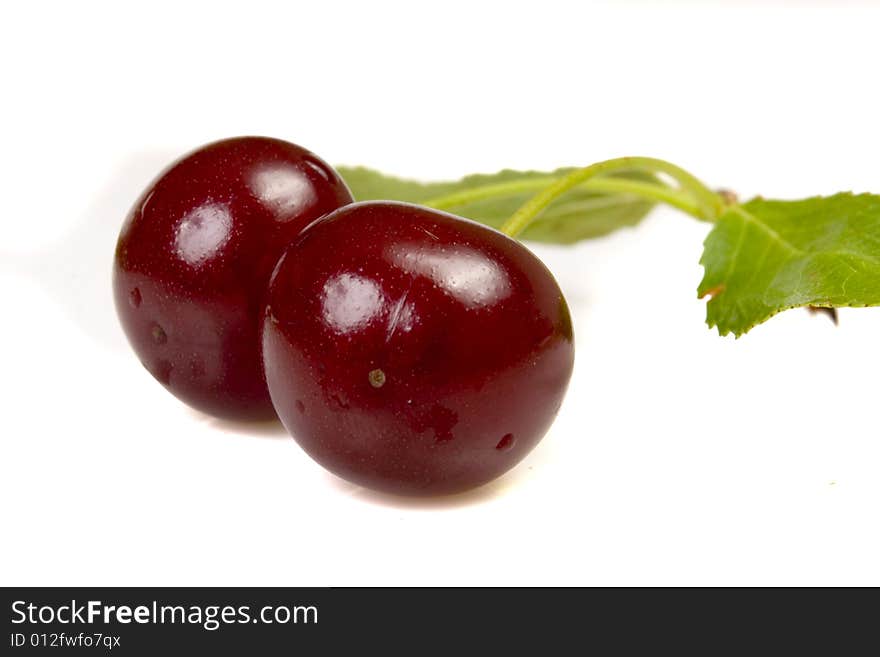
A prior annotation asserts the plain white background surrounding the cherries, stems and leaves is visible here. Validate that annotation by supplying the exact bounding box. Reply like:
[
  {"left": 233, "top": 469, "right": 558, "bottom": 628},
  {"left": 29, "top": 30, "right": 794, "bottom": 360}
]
[{"left": 0, "top": 0, "right": 880, "bottom": 585}]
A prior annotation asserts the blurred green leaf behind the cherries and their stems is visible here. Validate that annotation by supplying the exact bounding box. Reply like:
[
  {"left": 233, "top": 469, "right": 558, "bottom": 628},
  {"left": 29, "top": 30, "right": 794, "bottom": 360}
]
[{"left": 337, "top": 167, "right": 660, "bottom": 244}]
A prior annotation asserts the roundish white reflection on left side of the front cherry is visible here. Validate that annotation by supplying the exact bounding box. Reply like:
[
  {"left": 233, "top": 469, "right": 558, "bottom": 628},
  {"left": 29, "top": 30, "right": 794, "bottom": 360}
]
[{"left": 321, "top": 273, "right": 384, "bottom": 333}]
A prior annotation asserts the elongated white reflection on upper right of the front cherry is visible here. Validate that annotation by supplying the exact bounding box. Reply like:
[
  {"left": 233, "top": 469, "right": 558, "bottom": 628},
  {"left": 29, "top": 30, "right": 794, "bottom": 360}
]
[{"left": 391, "top": 245, "right": 511, "bottom": 308}]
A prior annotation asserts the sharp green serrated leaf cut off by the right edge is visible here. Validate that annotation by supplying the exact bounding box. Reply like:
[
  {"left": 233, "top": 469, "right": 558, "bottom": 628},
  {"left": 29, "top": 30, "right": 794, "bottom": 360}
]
[{"left": 698, "top": 193, "right": 880, "bottom": 337}]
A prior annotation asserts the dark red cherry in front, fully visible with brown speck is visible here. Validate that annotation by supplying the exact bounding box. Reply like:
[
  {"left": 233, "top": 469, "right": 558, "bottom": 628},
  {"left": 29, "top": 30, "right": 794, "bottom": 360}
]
[{"left": 262, "top": 202, "right": 574, "bottom": 495}]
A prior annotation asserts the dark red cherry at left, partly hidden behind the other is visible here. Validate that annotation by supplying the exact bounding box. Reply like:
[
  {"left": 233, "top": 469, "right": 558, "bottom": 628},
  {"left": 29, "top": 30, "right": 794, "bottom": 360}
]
[{"left": 113, "top": 137, "right": 352, "bottom": 420}]
